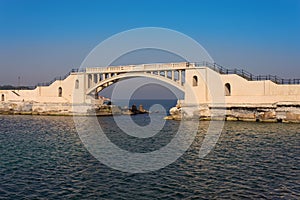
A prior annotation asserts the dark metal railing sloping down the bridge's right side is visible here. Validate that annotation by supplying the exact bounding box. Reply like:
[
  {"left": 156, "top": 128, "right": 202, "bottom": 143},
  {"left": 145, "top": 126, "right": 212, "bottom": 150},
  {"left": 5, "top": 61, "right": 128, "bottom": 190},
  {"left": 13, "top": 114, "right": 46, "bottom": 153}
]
[{"left": 195, "top": 62, "right": 300, "bottom": 84}]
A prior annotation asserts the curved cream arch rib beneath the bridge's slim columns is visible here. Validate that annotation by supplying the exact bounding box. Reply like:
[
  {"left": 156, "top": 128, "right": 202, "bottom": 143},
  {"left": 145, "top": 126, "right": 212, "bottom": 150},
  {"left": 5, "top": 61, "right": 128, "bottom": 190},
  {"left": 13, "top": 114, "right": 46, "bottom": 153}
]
[{"left": 86, "top": 72, "right": 184, "bottom": 95}]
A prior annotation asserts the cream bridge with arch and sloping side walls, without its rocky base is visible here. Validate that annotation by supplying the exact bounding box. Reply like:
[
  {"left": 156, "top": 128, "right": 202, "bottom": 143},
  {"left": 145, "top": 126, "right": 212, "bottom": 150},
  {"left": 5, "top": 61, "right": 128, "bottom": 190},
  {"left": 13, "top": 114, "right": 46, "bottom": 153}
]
[{"left": 0, "top": 62, "right": 300, "bottom": 108}]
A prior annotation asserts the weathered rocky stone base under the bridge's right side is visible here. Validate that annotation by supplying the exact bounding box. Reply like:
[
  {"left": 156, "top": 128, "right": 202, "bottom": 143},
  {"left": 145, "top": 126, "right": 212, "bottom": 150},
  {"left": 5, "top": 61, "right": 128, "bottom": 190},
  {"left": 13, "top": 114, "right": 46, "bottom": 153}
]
[{"left": 166, "top": 102, "right": 300, "bottom": 123}]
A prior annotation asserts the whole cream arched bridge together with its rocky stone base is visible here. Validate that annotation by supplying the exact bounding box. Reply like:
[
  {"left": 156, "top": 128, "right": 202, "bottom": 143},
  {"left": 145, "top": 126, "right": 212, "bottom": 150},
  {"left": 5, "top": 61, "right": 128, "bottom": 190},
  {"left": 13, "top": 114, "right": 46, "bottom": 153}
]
[{"left": 0, "top": 62, "right": 300, "bottom": 122}]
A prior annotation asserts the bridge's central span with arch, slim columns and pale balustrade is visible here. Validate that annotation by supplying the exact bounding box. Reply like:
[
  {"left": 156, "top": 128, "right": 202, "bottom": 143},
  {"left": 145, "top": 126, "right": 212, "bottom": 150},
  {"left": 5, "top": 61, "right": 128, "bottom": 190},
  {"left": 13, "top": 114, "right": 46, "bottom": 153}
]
[{"left": 85, "top": 63, "right": 190, "bottom": 95}]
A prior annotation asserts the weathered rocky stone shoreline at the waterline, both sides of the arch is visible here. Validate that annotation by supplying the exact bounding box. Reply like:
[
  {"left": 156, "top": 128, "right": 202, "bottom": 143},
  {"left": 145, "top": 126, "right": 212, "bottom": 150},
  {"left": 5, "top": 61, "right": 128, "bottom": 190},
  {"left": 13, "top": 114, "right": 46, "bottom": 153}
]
[{"left": 0, "top": 102, "right": 300, "bottom": 123}]
